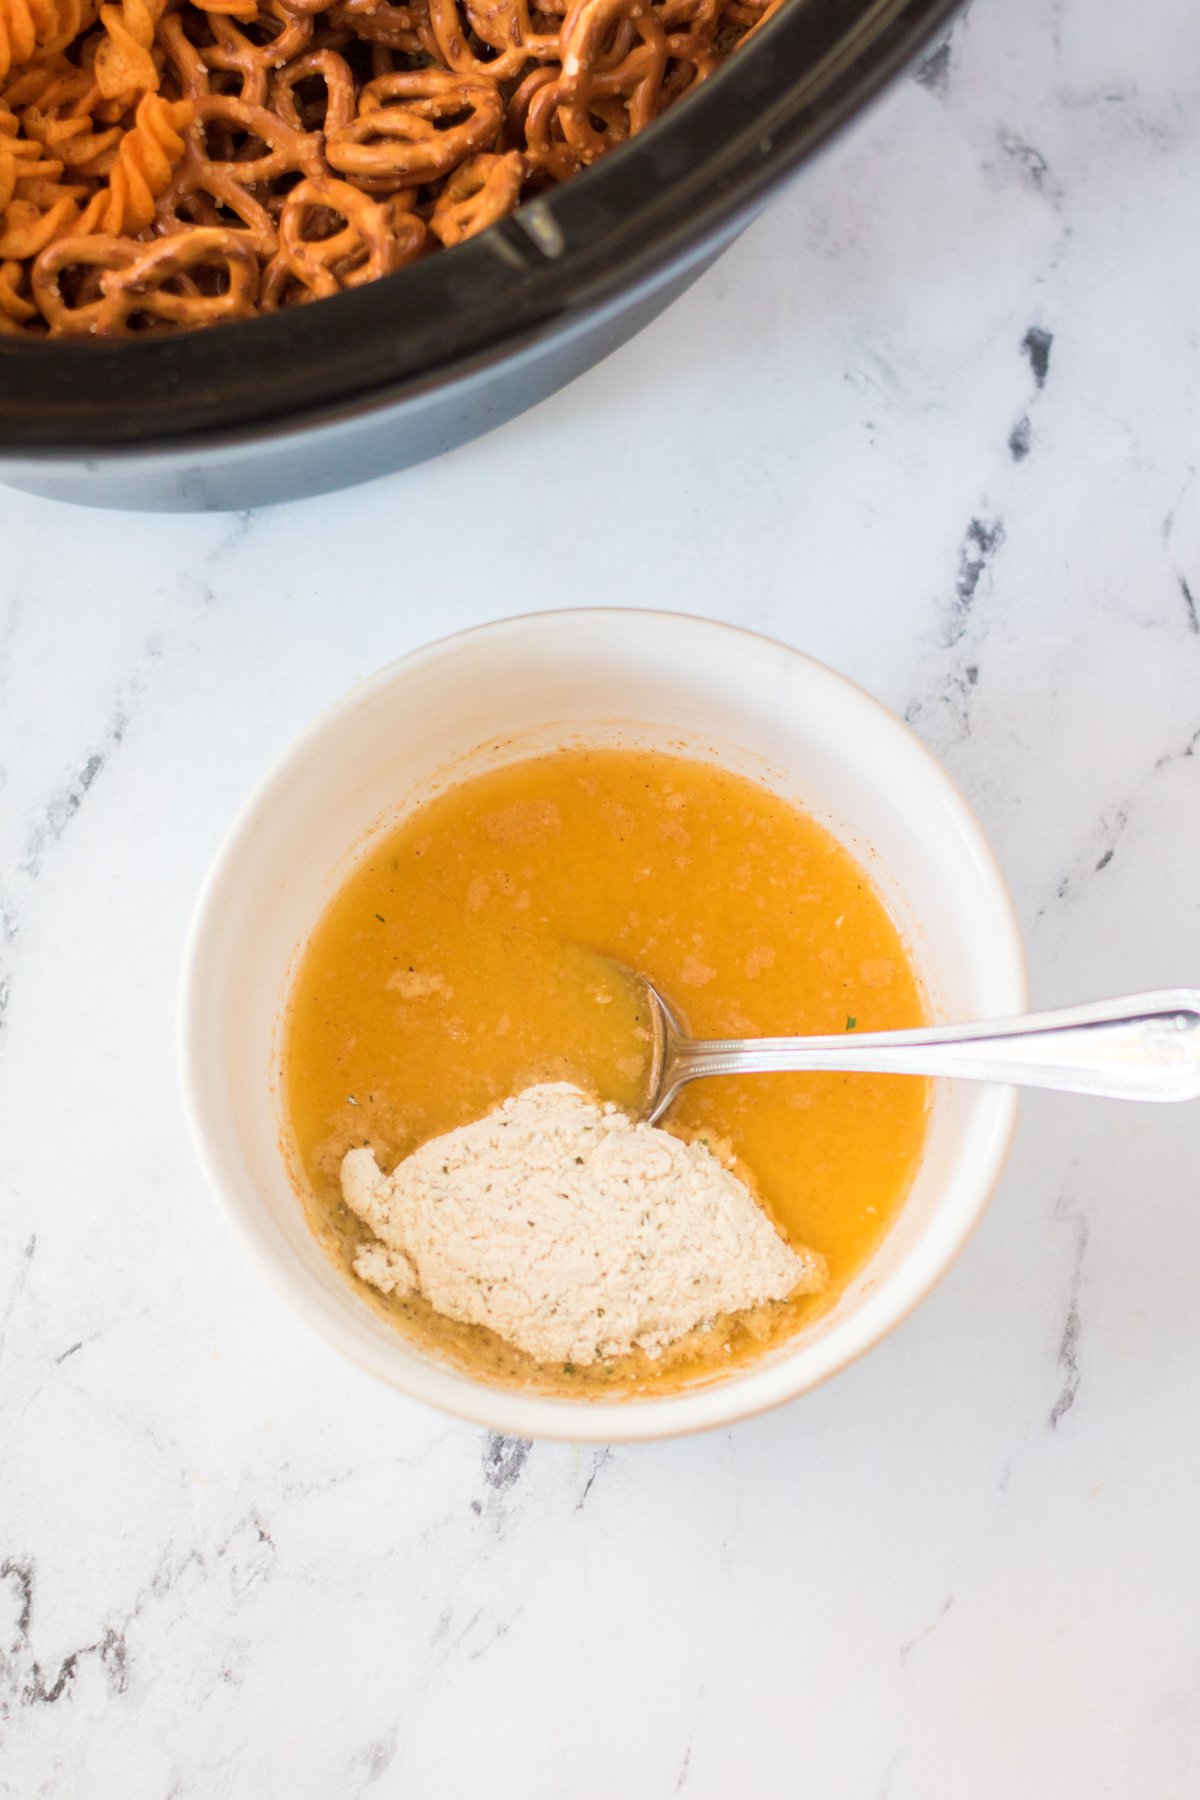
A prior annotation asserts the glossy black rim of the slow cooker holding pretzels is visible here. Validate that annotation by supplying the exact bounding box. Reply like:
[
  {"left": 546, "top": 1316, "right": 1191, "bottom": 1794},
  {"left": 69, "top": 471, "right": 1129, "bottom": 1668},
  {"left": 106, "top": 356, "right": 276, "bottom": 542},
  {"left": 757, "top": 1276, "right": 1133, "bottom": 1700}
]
[{"left": 0, "top": 0, "right": 963, "bottom": 466}]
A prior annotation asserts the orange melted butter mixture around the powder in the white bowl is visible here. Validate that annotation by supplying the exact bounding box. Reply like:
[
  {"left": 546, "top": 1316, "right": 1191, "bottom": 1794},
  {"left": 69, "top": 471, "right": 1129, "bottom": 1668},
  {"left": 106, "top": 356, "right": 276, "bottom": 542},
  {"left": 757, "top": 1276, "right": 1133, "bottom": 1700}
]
[{"left": 284, "top": 749, "right": 927, "bottom": 1393}]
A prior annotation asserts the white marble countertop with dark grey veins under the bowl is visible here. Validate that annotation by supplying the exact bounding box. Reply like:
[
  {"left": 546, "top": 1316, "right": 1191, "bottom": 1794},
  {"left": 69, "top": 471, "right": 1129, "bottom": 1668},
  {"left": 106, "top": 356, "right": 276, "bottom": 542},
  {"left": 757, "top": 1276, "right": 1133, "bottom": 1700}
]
[{"left": 0, "top": 0, "right": 1200, "bottom": 1800}]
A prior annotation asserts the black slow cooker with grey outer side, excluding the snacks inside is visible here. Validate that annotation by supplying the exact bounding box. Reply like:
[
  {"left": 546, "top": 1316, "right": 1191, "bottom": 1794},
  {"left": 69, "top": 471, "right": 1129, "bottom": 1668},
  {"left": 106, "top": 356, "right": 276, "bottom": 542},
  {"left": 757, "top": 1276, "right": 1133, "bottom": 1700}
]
[{"left": 0, "top": 0, "right": 959, "bottom": 511}]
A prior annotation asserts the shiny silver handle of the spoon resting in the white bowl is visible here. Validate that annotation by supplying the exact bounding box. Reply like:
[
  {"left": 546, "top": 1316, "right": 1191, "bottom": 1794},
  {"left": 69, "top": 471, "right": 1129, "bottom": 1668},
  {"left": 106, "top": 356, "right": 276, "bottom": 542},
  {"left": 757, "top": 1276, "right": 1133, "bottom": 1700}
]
[{"left": 664, "top": 988, "right": 1200, "bottom": 1100}]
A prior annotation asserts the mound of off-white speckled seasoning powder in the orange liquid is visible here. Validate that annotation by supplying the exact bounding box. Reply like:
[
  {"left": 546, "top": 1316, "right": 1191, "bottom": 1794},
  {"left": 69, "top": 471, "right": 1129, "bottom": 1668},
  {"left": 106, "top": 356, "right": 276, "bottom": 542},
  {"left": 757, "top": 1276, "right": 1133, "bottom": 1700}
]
[{"left": 342, "top": 1082, "right": 826, "bottom": 1364}]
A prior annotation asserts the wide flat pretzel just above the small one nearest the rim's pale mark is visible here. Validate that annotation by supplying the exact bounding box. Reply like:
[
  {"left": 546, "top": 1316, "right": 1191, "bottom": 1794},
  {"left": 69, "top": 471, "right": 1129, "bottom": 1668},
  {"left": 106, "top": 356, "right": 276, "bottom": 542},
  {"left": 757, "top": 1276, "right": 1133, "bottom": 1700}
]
[{"left": 326, "top": 68, "right": 504, "bottom": 184}]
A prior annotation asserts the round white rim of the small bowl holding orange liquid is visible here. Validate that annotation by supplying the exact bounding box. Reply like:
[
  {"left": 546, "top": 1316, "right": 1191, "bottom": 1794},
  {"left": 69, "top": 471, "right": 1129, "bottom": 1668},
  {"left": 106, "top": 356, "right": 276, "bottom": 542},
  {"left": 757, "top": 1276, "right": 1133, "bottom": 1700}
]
[{"left": 176, "top": 607, "right": 1029, "bottom": 1444}]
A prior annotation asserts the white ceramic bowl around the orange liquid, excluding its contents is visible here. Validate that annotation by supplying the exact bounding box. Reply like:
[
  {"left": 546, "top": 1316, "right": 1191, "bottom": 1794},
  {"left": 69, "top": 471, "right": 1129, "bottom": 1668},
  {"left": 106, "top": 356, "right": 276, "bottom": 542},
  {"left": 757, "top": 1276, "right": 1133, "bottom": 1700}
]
[{"left": 182, "top": 610, "right": 1025, "bottom": 1444}]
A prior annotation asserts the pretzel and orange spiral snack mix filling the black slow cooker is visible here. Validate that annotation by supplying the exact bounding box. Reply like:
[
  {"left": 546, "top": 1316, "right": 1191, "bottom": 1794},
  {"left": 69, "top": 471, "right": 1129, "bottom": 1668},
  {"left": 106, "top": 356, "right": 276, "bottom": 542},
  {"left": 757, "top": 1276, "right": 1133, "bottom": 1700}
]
[{"left": 0, "top": 0, "right": 766, "bottom": 337}]
